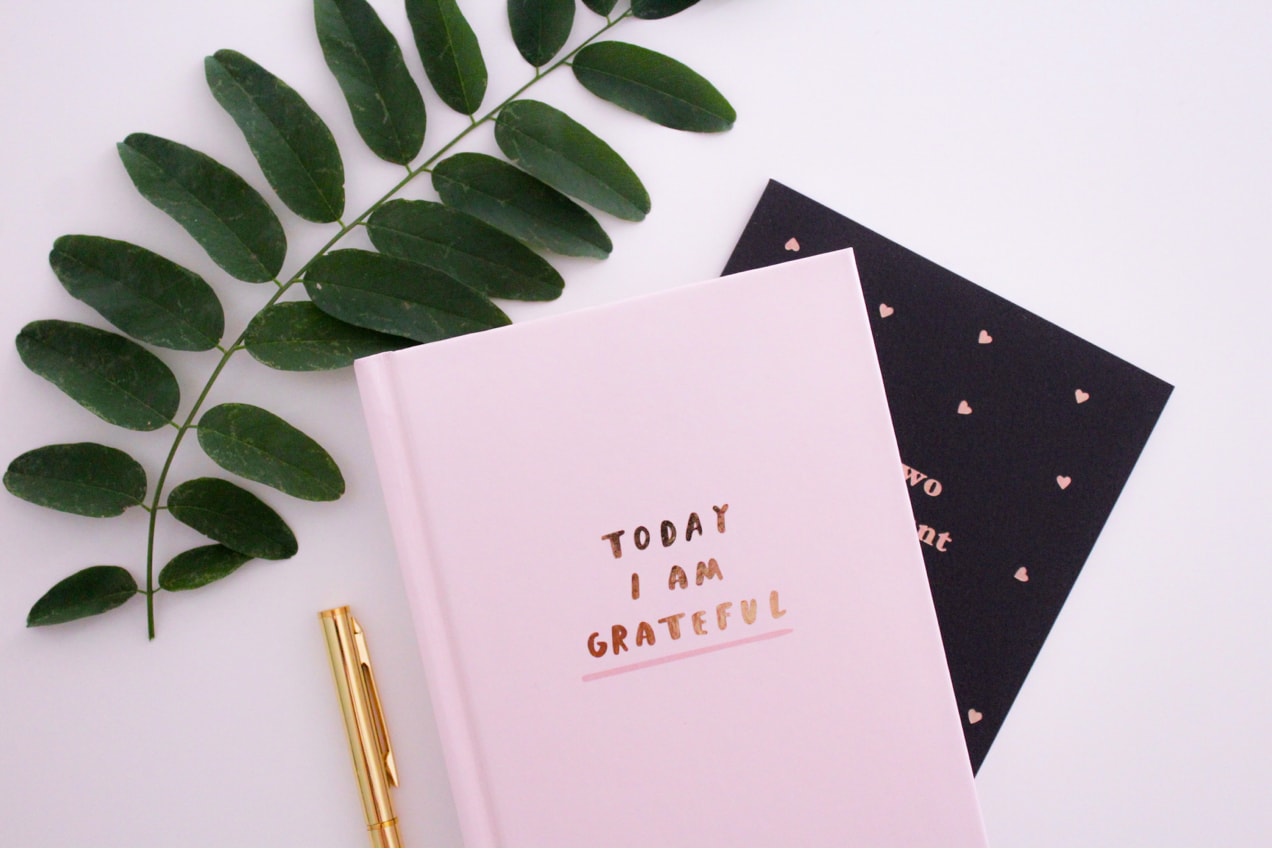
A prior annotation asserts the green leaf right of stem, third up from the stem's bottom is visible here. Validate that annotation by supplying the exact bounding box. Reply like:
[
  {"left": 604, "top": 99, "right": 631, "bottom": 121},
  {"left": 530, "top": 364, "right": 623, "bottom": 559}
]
[{"left": 198, "top": 405, "right": 345, "bottom": 501}]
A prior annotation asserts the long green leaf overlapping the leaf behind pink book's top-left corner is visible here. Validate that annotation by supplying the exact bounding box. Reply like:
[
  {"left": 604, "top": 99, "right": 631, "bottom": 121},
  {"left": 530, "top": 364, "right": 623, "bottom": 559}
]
[{"left": 305, "top": 249, "right": 509, "bottom": 342}]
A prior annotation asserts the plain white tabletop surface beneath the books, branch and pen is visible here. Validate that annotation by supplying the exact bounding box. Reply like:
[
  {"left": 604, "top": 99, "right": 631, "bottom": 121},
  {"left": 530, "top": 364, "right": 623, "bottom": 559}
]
[{"left": 0, "top": 0, "right": 1272, "bottom": 846}]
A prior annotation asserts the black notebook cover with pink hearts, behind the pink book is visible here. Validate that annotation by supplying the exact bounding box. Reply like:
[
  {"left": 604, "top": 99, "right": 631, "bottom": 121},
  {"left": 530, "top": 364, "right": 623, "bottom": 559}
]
[{"left": 724, "top": 181, "right": 1172, "bottom": 770}]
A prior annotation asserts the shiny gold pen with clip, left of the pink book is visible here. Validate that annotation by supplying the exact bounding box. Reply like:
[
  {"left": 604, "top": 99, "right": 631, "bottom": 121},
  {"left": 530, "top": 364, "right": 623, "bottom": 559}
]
[{"left": 318, "top": 606, "right": 402, "bottom": 847}]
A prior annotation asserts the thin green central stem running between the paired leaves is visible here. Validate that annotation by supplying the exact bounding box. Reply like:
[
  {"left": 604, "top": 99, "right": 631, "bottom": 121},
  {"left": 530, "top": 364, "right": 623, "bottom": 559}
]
[{"left": 140, "top": 9, "right": 631, "bottom": 640}]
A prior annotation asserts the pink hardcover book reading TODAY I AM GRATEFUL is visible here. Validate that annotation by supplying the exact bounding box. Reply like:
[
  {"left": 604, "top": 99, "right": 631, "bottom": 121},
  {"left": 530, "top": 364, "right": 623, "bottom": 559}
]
[{"left": 356, "top": 251, "right": 985, "bottom": 846}]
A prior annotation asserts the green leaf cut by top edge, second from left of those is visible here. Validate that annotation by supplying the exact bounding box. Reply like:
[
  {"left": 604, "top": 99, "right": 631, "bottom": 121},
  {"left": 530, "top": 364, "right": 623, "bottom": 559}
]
[{"left": 406, "top": 0, "right": 486, "bottom": 115}]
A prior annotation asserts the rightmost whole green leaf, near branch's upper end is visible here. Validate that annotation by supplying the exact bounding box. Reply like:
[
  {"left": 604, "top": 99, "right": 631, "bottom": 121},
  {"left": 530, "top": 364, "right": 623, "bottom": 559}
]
[{"left": 571, "top": 41, "right": 738, "bottom": 132}]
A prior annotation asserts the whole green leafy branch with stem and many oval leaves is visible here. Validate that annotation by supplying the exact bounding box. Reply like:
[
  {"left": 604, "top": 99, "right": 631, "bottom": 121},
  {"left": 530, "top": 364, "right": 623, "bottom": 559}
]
[{"left": 4, "top": 0, "right": 735, "bottom": 639}]
